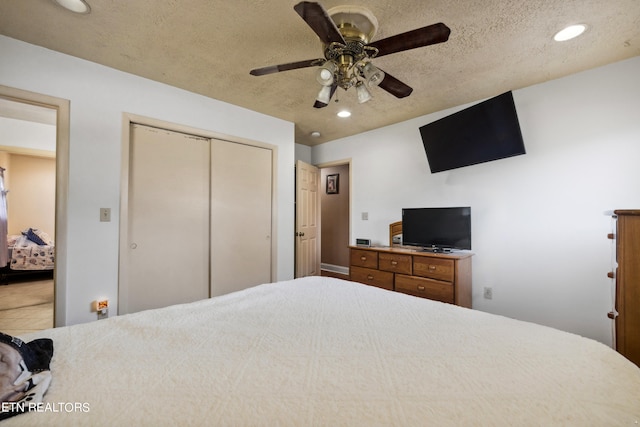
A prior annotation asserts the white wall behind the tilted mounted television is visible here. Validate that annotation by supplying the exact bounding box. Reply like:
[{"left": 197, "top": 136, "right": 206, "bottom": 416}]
[{"left": 312, "top": 57, "right": 640, "bottom": 344}]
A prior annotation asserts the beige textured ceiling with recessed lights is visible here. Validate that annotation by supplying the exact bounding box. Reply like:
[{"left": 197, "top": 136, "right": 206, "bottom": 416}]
[{"left": 0, "top": 0, "right": 640, "bottom": 145}]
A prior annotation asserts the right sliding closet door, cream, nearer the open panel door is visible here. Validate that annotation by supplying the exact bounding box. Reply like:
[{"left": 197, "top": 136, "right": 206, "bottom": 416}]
[{"left": 211, "top": 139, "right": 273, "bottom": 296}]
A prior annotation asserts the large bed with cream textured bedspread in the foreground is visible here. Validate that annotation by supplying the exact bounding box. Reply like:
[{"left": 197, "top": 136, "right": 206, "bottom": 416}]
[{"left": 3, "top": 277, "right": 640, "bottom": 427}]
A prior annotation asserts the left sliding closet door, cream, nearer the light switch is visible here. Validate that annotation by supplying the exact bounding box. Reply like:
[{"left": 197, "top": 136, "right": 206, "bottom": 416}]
[{"left": 119, "top": 124, "right": 210, "bottom": 314}]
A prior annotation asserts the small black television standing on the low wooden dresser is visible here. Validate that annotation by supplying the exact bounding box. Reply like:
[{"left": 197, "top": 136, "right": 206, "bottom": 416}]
[{"left": 402, "top": 207, "right": 471, "bottom": 251}]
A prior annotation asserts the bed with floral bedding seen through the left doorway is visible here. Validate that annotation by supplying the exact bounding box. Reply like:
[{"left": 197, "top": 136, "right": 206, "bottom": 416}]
[{"left": 0, "top": 228, "right": 55, "bottom": 284}]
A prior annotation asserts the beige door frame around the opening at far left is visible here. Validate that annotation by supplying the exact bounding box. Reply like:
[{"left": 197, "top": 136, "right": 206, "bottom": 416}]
[{"left": 0, "top": 85, "right": 71, "bottom": 327}]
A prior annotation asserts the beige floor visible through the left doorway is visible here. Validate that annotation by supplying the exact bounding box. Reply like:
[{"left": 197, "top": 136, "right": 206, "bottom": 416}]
[{"left": 0, "top": 280, "right": 53, "bottom": 336}]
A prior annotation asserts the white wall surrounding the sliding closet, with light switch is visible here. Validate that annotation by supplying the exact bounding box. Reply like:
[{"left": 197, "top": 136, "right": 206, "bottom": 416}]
[{"left": 0, "top": 36, "right": 294, "bottom": 324}]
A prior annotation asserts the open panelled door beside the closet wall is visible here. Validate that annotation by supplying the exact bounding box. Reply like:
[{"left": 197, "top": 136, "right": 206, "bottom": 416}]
[{"left": 295, "top": 160, "right": 320, "bottom": 278}]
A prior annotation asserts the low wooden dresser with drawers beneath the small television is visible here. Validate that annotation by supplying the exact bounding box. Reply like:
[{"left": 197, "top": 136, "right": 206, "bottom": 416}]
[{"left": 349, "top": 246, "right": 473, "bottom": 308}]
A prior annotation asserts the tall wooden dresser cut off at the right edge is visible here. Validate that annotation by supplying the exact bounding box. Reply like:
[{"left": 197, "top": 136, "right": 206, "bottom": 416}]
[{"left": 609, "top": 210, "right": 640, "bottom": 366}]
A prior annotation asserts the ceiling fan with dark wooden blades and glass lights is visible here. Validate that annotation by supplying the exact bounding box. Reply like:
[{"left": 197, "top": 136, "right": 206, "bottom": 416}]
[{"left": 250, "top": 1, "right": 451, "bottom": 108}]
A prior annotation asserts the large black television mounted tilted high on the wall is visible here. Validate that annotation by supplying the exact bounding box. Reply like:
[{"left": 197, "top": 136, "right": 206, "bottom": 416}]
[{"left": 420, "top": 92, "right": 525, "bottom": 173}]
